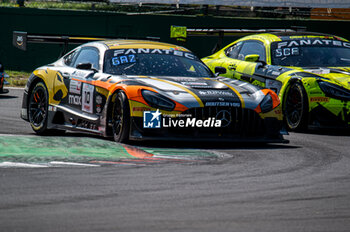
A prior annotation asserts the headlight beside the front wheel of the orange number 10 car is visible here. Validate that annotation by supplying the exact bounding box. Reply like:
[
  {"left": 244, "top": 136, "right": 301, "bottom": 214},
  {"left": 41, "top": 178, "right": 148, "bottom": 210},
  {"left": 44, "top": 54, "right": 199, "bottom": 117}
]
[{"left": 141, "top": 89, "right": 175, "bottom": 111}]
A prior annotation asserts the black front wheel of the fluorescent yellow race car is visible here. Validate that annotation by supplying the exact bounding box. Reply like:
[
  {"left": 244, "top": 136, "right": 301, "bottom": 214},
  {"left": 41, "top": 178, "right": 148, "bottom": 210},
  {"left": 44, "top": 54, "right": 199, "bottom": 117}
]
[{"left": 283, "top": 82, "right": 308, "bottom": 131}]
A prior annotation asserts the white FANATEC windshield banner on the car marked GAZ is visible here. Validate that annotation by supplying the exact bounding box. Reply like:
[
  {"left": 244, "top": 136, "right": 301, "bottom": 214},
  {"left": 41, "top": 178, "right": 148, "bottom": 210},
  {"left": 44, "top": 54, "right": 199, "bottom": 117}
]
[{"left": 113, "top": 48, "right": 196, "bottom": 59}]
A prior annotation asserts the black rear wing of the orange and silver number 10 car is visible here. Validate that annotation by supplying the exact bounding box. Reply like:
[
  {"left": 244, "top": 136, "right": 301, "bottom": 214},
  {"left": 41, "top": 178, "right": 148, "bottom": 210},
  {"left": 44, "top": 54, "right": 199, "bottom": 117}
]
[{"left": 12, "top": 31, "right": 160, "bottom": 55}]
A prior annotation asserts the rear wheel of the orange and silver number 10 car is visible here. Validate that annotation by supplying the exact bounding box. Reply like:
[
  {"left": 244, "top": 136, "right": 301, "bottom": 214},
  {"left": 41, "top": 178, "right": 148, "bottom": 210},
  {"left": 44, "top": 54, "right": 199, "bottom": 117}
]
[{"left": 28, "top": 82, "right": 49, "bottom": 134}]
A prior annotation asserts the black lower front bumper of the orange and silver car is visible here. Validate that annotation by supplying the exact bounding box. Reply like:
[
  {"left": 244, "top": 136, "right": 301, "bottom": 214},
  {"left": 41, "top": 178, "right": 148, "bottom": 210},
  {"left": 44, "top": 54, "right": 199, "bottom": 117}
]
[{"left": 130, "top": 112, "right": 289, "bottom": 143}]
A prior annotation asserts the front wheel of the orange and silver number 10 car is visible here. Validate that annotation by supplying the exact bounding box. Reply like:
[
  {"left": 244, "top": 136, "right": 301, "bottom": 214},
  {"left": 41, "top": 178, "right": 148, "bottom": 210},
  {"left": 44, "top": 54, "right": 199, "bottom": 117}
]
[{"left": 112, "top": 91, "right": 130, "bottom": 142}]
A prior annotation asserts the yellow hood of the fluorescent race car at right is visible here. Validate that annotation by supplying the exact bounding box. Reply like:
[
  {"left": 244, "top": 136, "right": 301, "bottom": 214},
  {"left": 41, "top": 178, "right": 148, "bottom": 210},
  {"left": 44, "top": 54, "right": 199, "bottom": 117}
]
[{"left": 292, "top": 67, "right": 350, "bottom": 89}]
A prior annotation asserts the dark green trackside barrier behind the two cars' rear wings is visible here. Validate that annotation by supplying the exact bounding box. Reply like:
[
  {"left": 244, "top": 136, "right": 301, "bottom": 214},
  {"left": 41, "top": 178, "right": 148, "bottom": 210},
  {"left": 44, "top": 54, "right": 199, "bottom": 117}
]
[{"left": 0, "top": 8, "right": 350, "bottom": 71}]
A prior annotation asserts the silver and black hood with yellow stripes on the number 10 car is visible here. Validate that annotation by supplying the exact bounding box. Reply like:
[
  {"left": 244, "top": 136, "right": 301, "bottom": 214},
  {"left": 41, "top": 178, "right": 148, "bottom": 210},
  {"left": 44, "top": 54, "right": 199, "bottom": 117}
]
[{"left": 127, "top": 76, "right": 265, "bottom": 109}]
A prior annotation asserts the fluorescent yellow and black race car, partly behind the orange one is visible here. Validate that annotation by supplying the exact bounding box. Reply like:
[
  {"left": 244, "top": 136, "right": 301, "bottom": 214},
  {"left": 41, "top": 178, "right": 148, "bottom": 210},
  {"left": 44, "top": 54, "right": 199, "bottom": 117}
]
[{"left": 202, "top": 32, "right": 350, "bottom": 130}]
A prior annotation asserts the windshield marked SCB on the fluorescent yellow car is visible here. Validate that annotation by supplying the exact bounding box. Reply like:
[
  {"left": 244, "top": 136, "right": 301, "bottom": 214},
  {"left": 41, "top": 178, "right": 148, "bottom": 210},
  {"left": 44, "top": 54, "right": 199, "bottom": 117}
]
[{"left": 271, "top": 39, "right": 350, "bottom": 67}]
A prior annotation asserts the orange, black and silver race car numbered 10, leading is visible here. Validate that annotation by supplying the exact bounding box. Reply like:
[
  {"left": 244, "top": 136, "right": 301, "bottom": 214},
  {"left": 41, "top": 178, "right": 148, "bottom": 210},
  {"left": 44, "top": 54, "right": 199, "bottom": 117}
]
[{"left": 21, "top": 40, "right": 286, "bottom": 142}]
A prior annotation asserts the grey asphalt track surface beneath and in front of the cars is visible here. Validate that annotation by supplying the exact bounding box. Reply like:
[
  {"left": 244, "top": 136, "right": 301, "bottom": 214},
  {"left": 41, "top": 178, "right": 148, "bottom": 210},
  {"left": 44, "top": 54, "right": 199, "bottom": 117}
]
[{"left": 0, "top": 89, "right": 350, "bottom": 232}]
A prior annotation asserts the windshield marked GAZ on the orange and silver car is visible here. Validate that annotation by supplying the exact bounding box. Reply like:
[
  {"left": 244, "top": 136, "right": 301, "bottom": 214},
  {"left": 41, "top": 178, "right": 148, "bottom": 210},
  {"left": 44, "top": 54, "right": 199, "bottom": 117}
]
[{"left": 104, "top": 49, "right": 213, "bottom": 77}]
